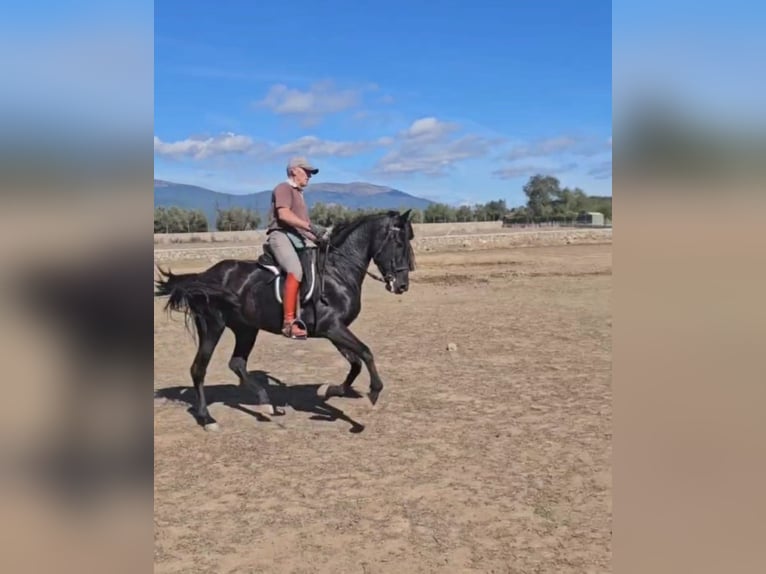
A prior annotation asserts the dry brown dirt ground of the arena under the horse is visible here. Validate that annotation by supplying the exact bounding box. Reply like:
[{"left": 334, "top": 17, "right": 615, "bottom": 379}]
[{"left": 154, "top": 243, "right": 612, "bottom": 574}]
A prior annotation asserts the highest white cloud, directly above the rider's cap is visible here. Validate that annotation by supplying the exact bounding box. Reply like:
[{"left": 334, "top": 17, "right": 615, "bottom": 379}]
[{"left": 255, "top": 81, "right": 370, "bottom": 124}]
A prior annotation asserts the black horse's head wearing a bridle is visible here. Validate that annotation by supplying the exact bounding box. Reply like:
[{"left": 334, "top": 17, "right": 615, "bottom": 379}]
[{"left": 372, "top": 209, "right": 415, "bottom": 295}]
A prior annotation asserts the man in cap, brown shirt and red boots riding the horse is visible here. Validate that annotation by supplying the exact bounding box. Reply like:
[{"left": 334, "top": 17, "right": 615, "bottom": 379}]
[{"left": 267, "top": 157, "right": 329, "bottom": 339}]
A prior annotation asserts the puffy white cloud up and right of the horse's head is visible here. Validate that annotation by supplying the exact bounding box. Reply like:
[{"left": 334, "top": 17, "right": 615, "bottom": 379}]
[{"left": 375, "top": 117, "right": 492, "bottom": 175}]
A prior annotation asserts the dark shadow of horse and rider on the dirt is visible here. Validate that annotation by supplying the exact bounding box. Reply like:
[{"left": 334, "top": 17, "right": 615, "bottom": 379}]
[{"left": 154, "top": 371, "right": 364, "bottom": 433}]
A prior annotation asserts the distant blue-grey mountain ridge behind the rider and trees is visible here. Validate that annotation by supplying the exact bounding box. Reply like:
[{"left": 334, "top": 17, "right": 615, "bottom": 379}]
[{"left": 154, "top": 179, "right": 433, "bottom": 229}]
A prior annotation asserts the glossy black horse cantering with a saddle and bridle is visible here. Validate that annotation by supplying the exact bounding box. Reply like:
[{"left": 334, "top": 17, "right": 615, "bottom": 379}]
[{"left": 155, "top": 210, "right": 415, "bottom": 429}]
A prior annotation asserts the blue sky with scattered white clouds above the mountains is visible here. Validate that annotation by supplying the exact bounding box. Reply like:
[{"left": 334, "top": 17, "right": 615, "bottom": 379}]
[{"left": 154, "top": 0, "right": 612, "bottom": 206}]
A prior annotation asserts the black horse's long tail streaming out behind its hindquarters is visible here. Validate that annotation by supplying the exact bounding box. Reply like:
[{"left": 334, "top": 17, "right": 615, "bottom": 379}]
[{"left": 154, "top": 265, "right": 240, "bottom": 328}]
